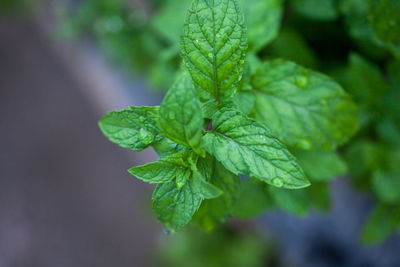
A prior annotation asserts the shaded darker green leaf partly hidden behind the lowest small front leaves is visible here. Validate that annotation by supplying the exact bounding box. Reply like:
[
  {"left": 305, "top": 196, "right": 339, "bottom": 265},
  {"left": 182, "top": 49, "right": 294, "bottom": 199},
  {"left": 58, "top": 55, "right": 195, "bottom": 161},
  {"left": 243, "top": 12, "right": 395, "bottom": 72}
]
[{"left": 193, "top": 159, "right": 240, "bottom": 231}]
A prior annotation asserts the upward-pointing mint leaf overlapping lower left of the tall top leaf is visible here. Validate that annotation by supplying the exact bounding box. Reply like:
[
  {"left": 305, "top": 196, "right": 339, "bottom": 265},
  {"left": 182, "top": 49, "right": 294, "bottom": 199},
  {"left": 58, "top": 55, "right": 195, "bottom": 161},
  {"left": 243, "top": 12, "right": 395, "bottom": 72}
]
[{"left": 158, "top": 72, "right": 204, "bottom": 155}]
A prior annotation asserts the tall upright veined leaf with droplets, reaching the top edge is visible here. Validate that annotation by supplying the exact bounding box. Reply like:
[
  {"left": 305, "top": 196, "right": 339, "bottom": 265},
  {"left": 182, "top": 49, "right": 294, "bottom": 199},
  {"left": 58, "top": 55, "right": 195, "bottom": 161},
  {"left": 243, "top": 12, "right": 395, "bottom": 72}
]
[{"left": 181, "top": 0, "right": 247, "bottom": 100}]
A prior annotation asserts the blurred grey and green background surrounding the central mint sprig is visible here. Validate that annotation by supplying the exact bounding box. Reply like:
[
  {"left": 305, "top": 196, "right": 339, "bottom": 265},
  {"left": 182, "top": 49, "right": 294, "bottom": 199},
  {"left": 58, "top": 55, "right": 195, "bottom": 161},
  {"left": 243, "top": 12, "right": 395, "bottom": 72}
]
[{"left": 0, "top": 0, "right": 400, "bottom": 267}]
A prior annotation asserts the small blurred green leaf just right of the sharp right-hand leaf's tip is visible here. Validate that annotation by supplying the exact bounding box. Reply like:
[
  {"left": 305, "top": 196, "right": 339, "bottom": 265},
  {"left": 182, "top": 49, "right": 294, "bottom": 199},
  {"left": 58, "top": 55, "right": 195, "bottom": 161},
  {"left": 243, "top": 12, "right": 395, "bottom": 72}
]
[{"left": 293, "top": 150, "right": 347, "bottom": 181}]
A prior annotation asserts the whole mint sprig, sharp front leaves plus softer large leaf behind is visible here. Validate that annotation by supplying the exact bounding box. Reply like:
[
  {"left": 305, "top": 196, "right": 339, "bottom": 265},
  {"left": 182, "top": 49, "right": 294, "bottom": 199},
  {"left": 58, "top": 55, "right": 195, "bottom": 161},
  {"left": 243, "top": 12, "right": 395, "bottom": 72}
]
[{"left": 99, "top": 0, "right": 358, "bottom": 232}]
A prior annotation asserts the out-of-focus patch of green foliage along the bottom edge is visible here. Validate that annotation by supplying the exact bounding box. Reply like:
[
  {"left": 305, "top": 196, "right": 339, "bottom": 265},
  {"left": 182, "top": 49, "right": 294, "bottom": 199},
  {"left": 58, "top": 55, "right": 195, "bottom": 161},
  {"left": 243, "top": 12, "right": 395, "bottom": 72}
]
[{"left": 157, "top": 226, "right": 277, "bottom": 267}]
